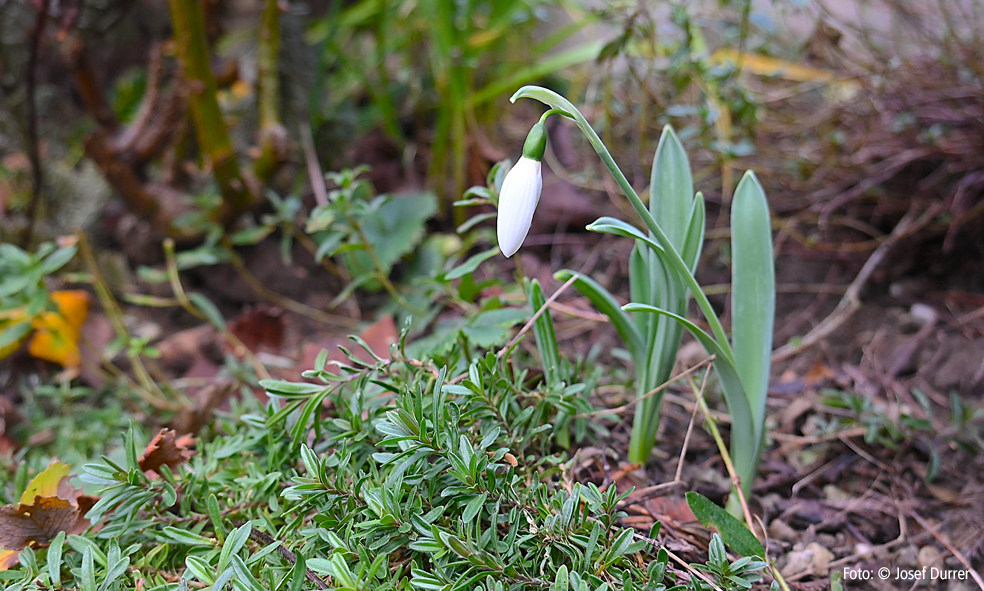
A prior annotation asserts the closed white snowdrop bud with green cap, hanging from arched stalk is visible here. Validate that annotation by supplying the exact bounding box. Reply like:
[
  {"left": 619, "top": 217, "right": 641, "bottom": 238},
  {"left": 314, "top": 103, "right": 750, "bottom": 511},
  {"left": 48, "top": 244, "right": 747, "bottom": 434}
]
[{"left": 496, "top": 121, "right": 547, "bottom": 258}]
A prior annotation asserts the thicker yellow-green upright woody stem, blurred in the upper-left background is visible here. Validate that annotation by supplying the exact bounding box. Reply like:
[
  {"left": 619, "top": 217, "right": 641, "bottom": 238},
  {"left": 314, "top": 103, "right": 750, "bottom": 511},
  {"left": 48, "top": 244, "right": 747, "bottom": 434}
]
[{"left": 168, "top": 0, "right": 256, "bottom": 223}]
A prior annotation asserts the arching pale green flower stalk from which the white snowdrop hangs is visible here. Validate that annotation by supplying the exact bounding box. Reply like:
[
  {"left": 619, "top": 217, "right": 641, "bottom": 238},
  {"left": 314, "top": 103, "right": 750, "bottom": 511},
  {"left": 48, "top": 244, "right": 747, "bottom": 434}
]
[{"left": 509, "top": 86, "right": 735, "bottom": 365}]
